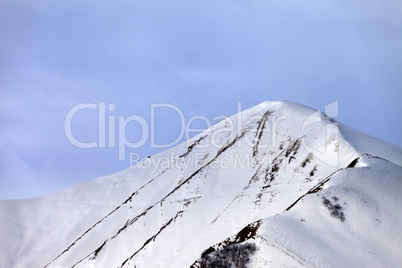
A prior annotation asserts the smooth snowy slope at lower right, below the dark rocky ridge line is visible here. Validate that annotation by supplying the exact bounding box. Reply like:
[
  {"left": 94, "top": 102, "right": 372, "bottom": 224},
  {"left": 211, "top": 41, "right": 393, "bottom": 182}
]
[{"left": 252, "top": 156, "right": 402, "bottom": 267}]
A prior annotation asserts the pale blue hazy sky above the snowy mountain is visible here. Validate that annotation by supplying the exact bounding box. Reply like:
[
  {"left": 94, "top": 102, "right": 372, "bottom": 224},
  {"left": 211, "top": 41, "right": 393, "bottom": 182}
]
[{"left": 0, "top": 0, "right": 402, "bottom": 199}]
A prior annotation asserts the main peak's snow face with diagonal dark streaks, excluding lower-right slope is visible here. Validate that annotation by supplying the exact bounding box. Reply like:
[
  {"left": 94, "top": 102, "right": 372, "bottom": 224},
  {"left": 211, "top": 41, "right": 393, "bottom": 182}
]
[{"left": 0, "top": 101, "right": 402, "bottom": 267}]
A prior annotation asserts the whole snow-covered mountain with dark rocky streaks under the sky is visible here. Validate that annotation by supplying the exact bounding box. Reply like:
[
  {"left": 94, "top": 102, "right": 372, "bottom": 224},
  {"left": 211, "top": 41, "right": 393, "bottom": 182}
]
[{"left": 0, "top": 101, "right": 402, "bottom": 268}]
